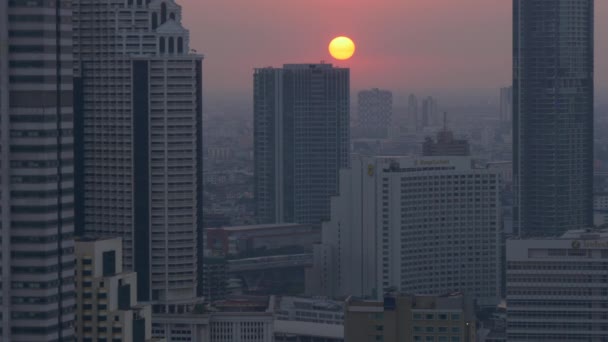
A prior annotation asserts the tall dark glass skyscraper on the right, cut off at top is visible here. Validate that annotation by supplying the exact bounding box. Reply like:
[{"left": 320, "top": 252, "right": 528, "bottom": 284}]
[{"left": 513, "top": 0, "right": 594, "bottom": 236}]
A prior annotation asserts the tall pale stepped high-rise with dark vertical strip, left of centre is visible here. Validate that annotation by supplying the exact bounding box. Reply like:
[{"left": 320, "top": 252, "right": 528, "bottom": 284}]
[{"left": 73, "top": 0, "right": 203, "bottom": 304}]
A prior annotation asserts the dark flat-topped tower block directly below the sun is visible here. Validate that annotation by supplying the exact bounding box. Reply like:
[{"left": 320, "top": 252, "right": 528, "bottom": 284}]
[{"left": 254, "top": 64, "right": 350, "bottom": 224}]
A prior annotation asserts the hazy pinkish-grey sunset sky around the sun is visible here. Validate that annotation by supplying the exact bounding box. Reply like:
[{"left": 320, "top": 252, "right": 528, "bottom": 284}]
[{"left": 177, "top": 0, "right": 608, "bottom": 104}]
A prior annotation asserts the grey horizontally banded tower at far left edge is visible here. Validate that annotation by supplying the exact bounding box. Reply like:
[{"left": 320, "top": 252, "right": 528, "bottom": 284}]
[{"left": 0, "top": 0, "right": 75, "bottom": 342}]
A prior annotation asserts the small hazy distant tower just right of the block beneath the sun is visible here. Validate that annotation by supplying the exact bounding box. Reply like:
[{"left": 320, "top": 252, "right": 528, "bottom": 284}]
[{"left": 357, "top": 88, "right": 393, "bottom": 139}]
